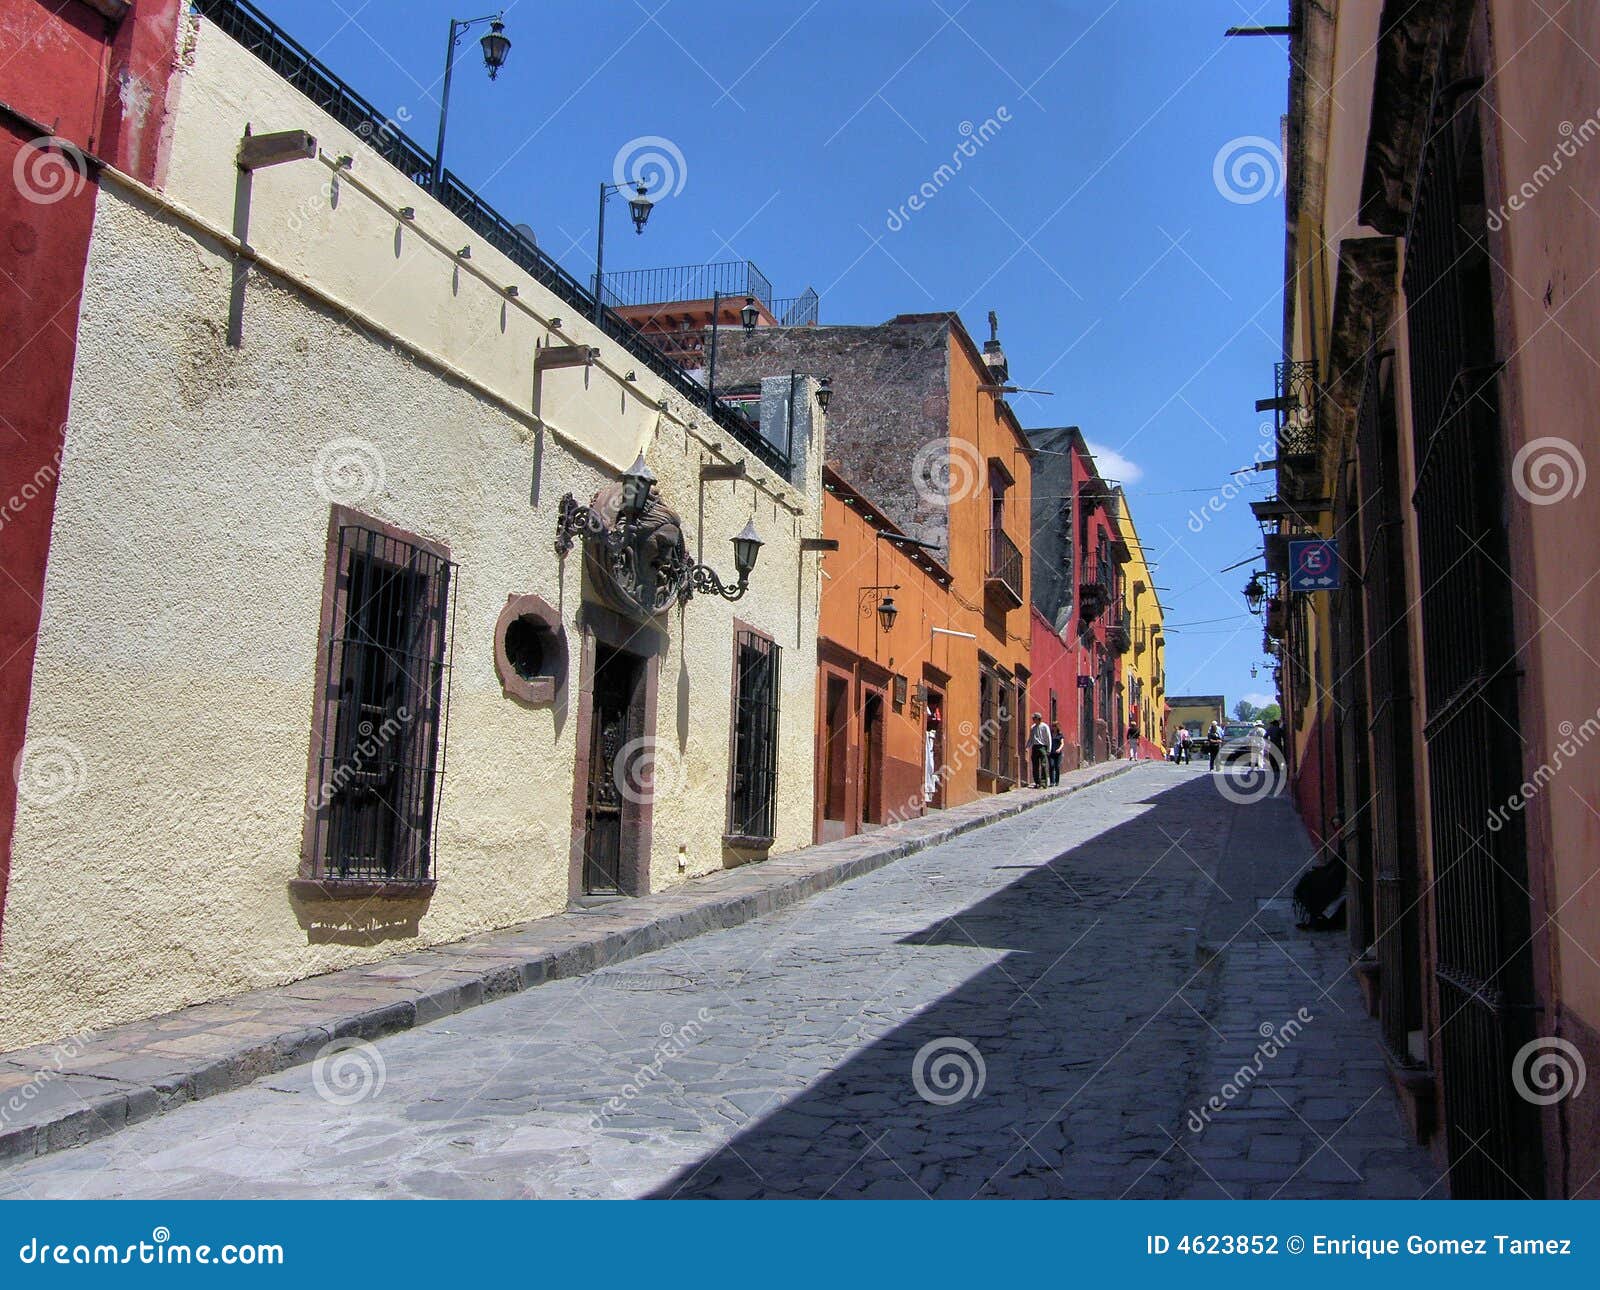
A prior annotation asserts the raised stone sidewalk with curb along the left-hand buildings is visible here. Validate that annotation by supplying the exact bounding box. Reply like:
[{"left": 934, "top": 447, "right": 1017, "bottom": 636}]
[{"left": 0, "top": 762, "right": 1144, "bottom": 1164}]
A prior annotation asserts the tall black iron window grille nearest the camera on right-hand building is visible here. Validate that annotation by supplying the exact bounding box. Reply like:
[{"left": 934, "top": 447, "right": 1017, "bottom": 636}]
[{"left": 1405, "top": 73, "right": 1542, "bottom": 1197}]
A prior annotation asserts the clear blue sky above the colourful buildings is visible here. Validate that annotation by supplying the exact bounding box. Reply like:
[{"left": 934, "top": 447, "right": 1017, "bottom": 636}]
[{"left": 256, "top": 0, "right": 1288, "bottom": 704}]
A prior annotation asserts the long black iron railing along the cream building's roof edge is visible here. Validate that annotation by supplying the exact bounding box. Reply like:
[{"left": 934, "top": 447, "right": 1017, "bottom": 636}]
[{"left": 190, "top": 0, "right": 790, "bottom": 474}]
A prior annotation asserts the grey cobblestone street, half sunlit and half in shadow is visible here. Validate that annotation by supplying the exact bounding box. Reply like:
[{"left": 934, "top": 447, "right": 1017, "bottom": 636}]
[{"left": 0, "top": 763, "right": 1445, "bottom": 1197}]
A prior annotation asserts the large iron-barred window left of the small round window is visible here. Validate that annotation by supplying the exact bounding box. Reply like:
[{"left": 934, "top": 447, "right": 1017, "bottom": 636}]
[{"left": 302, "top": 507, "right": 454, "bottom": 883}]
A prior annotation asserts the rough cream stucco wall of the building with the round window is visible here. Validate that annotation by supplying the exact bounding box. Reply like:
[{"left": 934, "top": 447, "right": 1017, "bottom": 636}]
[{"left": 0, "top": 12, "right": 822, "bottom": 1050}]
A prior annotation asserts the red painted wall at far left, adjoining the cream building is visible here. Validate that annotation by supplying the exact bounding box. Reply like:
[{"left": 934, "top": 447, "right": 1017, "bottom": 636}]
[{"left": 0, "top": 0, "right": 181, "bottom": 935}]
